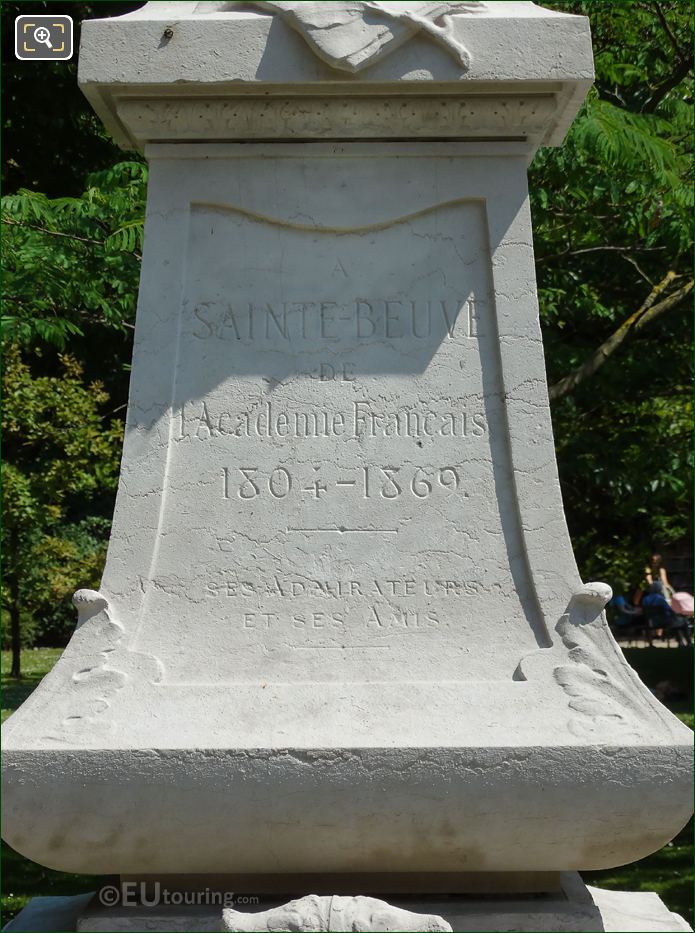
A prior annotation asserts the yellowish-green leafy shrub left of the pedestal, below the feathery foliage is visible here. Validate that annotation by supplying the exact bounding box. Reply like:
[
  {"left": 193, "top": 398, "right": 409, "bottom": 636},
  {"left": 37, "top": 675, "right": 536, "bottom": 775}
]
[{"left": 2, "top": 345, "right": 122, "bottom": 676}]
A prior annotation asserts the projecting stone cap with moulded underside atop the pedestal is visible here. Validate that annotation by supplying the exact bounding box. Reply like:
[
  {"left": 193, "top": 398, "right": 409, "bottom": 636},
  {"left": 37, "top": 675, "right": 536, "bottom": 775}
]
[{"left": 80, "top": 0, "right": 593, "bottom": 148}]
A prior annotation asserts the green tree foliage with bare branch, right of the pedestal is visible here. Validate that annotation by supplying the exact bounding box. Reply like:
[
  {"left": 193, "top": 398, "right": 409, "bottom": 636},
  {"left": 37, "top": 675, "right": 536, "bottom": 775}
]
[{"left": 531, "top": 0, "right": 693, "bottom": 583}]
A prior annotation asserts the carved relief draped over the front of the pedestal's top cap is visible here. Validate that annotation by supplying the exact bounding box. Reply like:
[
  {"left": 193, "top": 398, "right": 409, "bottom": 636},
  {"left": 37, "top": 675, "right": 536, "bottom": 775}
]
[{"left": 195, "top": 0, "right": 486, "bottom": 74}]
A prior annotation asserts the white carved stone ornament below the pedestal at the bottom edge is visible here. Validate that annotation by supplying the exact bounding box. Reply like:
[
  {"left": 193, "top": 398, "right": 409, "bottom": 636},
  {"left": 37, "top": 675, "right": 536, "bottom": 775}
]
[{"left": 221, "top": 894, "right": 451, "bottom": 933}]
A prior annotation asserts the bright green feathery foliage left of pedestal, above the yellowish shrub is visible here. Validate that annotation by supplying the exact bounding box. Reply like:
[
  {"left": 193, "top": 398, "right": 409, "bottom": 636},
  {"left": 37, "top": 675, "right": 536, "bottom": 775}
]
[{"left": 2, "top": 162, "right": 147, "bottom": 349}]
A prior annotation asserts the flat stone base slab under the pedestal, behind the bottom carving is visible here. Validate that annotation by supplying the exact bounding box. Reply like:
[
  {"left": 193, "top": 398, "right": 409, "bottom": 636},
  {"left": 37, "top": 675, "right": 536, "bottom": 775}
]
[{"left": 3, "top": 872, "right": 692, "bottom": 933}]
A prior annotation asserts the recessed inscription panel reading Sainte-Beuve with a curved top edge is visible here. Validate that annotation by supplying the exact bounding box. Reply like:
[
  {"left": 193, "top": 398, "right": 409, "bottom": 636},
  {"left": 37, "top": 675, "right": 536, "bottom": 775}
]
[{"left": 133, "top": 195, "right": 541, "bottom": 683}]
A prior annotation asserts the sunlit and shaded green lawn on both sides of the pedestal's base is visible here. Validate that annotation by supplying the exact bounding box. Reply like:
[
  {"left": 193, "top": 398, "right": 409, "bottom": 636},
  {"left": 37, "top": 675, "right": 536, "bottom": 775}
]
[{"left": 2, "top": 648, "right": 693, "bottom": 925}]
